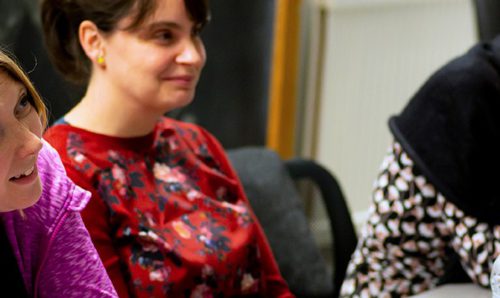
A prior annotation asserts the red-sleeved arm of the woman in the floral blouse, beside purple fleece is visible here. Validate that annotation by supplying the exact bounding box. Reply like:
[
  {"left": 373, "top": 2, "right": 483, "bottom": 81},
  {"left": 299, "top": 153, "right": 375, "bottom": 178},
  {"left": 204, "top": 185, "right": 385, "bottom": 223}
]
[{"left": 66, "top": 166, "right": 129, "bottom": 298}]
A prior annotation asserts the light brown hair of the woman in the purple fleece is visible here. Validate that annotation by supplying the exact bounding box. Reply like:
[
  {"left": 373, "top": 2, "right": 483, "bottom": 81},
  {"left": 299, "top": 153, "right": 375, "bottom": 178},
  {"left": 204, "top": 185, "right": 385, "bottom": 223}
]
[{"left": 0, "top": 49, "right": 47, "bottom": 127}]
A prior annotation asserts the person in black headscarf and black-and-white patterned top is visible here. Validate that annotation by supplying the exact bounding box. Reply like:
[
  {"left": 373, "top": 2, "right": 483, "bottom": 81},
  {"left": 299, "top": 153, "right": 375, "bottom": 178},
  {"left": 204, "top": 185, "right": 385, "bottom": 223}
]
[{"left": 341, "top": 38, "right": 500, "bottom": 297}]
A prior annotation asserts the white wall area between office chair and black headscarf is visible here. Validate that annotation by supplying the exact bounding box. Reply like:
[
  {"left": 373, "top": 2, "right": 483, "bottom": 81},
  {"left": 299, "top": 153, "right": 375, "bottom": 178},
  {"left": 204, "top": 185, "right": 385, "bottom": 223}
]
[{"left": 316, "top": 0, "right": 476, "bottom": 228}]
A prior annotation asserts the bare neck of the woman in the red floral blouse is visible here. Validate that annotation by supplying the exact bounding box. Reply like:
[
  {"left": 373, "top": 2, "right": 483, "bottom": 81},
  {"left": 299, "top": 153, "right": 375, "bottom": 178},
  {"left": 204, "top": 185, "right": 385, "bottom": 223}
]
[{"left": 65, "top": 73, "right": 162, "bottom": 137}]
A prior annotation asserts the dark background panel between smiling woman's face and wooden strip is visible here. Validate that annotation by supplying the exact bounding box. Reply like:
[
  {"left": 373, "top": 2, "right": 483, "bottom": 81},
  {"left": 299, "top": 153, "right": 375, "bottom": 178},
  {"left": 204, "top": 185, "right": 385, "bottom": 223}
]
[{"left": 171, "top": 0, "right": 275, "bottom": 148}]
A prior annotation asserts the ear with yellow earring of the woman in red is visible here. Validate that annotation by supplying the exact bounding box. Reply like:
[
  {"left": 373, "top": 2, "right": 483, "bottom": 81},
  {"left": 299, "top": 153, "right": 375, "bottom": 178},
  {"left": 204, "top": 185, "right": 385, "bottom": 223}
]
[{"left": 78, "top": 20, "right": 104, "bottom": 65}]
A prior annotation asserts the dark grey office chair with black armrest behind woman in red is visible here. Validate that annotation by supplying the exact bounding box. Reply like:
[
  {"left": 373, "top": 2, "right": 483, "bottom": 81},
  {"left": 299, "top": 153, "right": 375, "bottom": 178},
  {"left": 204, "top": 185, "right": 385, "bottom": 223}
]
[{"left": 228, "top": 147, "right": 356, "bottom": 298}]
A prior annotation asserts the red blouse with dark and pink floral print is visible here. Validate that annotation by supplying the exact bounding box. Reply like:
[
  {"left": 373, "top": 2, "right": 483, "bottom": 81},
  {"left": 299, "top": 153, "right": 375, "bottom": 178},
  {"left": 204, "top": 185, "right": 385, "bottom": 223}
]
[{"left": 44, "top": 118, "right": 293, "bottom": 297}]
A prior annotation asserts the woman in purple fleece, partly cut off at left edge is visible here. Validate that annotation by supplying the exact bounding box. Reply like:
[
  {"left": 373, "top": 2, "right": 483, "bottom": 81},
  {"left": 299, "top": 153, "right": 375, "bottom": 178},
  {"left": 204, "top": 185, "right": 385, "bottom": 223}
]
[{"left": 0, "top": 51, "right": 117, "bottom": 297}]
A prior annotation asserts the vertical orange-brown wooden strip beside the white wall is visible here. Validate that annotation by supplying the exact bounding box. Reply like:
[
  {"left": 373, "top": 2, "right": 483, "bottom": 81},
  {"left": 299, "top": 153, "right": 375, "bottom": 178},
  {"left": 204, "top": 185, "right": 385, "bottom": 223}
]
[{"left": 267, "top": 0, "right": 301, "bottom": 158}]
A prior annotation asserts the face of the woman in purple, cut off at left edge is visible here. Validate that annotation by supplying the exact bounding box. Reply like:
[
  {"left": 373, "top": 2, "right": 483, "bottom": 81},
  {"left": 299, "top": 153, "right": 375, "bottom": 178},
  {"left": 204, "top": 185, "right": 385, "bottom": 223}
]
[{"left": 0, "top": 70, "right": 42, "bottom": 212}]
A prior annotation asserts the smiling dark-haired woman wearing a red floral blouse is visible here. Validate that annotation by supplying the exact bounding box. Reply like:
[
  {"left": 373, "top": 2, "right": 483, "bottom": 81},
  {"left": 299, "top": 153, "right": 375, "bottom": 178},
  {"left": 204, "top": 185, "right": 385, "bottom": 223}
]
[{"left": 42, "top": 0, "right": 293, "bottom": 297}]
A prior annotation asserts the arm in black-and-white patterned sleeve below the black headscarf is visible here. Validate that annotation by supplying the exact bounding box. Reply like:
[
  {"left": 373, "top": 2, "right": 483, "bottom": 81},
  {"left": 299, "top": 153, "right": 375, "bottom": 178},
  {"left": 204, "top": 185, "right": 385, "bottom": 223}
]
[{"left": 341, "top": 143, "right": 451, "bottom": 297}]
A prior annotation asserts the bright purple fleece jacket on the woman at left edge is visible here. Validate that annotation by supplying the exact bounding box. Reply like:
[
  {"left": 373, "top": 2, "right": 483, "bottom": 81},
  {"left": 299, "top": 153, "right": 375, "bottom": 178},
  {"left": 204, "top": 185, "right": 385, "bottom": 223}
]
[{"left": 0, "top": 141, "right": 117, "bottom": 298}]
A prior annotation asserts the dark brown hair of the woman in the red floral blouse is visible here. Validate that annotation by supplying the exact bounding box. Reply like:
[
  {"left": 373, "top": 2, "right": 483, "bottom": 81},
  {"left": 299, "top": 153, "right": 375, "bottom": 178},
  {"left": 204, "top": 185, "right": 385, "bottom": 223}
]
[{"left": 41, "top": 0, "right": 209, "bottom": 84}]
